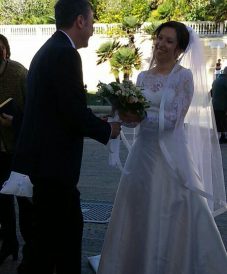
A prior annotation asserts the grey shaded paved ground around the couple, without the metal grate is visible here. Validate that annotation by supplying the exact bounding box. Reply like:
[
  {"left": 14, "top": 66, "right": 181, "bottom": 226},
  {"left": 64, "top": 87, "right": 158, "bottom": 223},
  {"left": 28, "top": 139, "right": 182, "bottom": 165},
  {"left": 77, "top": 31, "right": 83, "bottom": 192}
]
[{"left": 0, "top": 139, "right": 227, "bottom": 274}]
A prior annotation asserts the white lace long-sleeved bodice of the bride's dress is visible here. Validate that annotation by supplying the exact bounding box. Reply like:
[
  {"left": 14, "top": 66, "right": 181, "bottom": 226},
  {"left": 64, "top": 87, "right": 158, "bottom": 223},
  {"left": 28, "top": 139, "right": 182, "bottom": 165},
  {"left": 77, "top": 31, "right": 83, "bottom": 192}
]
[{"left": 137, "top": 66, "right": 193, "bottom": 129}]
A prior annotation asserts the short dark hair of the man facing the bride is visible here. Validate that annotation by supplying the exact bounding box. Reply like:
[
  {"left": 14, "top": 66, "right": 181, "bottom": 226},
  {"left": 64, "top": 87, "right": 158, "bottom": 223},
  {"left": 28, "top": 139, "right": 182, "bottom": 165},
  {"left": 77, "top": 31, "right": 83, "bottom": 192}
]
[{"left": 54, "top": 0, "right": 92, "bottom": 29}]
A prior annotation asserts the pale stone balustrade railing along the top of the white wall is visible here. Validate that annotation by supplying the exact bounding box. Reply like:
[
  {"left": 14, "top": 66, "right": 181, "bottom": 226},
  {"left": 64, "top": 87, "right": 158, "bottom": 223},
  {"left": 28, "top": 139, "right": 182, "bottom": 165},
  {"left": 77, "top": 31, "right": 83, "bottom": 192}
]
[{"left": 0, "top": 21, "right": 227, "bottom": 37}]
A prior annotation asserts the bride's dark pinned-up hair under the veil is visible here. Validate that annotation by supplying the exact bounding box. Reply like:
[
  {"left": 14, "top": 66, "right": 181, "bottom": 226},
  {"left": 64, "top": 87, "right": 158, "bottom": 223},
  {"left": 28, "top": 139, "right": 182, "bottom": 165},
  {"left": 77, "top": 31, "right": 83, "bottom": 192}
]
[{"left": 154, "top": 21, "right": 190, "bottom": 51}]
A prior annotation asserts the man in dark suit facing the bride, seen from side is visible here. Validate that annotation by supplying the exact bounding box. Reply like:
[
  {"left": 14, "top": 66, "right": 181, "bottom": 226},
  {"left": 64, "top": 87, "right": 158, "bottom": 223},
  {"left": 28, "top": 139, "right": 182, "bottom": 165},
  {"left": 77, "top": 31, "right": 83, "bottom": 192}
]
[{"left": 13, "top": 0, "right": 120, "bottom": 274}]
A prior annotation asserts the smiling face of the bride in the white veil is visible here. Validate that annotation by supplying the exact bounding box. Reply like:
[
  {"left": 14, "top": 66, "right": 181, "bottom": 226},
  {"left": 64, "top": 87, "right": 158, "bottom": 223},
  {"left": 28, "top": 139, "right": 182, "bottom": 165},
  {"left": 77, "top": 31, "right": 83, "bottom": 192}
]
[{"left": 154, "top": 27, "right": 180, "bottom": 63}]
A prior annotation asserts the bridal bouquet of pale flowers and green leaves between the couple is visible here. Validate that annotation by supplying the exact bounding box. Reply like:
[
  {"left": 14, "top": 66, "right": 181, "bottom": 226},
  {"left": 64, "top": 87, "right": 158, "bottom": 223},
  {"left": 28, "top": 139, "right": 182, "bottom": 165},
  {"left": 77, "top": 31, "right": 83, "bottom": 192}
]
[{"left": 96, "top": 80, "right": 149, "bottom": 118}]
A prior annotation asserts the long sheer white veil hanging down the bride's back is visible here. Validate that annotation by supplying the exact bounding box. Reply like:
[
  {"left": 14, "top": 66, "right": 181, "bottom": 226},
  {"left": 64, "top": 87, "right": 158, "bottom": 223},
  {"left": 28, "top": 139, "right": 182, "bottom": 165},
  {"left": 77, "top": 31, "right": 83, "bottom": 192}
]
[{"left": 159, "top": 25, "right": 227, "bottom": 216}]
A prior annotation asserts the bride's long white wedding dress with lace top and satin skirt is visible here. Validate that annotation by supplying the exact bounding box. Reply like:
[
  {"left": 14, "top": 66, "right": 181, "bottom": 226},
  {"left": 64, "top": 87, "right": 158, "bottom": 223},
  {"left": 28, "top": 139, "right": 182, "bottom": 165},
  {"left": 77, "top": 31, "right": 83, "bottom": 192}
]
[{"left": 98, "top": 66, "right": 227, "bottom": 274}]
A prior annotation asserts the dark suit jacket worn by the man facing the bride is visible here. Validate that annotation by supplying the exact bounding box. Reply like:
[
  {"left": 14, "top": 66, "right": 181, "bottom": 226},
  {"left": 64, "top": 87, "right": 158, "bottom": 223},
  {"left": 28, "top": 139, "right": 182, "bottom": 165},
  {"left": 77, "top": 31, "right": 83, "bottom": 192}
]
[{"left": 13, "top": 31, "right": 111, "bottom": 181}]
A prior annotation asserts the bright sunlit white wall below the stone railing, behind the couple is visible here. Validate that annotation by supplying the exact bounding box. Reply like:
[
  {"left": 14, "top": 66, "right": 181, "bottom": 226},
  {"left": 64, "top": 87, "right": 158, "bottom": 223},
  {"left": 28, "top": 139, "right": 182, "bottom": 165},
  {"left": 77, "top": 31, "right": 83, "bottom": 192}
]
[{"left": 5, "top": 34, "right": 227, "bottom": 91}]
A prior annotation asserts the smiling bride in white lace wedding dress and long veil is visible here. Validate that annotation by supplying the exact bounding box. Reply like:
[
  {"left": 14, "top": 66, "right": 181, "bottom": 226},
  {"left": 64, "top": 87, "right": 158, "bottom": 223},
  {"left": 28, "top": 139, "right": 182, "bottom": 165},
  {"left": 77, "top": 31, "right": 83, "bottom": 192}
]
[{"left": 98, "top": 21, "right": 227, "bottom": 274}]
